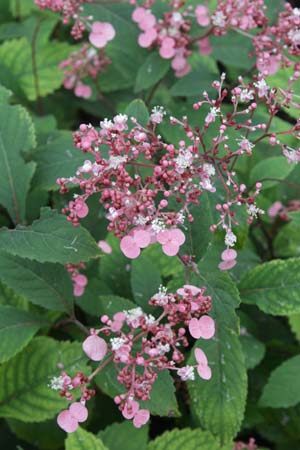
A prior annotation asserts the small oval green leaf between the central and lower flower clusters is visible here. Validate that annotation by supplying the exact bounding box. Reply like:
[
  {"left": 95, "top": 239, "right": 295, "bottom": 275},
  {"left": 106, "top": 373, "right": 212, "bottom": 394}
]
[{"left": 131, "top": 254, "right": 162, "bottom": 311}]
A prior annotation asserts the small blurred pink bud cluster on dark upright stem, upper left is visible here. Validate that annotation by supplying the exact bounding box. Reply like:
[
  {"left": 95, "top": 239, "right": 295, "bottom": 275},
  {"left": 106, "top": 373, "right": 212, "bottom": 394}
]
[{"left": 59, "top": 44, "right": 111, "bottom": 98}]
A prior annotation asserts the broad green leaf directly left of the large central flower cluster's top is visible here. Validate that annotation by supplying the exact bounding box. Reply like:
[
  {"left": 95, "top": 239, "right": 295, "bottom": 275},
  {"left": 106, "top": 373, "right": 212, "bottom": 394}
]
[{"left": 33, "top": 132, "right": 86, "bottom": 190}]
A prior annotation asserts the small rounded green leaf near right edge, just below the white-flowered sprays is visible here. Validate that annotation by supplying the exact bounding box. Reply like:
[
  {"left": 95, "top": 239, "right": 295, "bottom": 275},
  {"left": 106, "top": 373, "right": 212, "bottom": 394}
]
[{"left": 250, "top": 156, "right": 295, "bottom": 190}]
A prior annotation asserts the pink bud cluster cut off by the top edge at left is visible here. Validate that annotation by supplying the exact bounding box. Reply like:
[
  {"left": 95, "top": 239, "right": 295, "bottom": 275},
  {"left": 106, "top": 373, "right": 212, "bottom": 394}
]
[{"left": 35, "top": 0, "right": 94, "bottom": 39}]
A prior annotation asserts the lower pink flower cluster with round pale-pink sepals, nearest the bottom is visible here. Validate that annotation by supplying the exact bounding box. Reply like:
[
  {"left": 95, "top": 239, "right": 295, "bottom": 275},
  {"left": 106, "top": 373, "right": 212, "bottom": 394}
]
[{"left": 50, "top": 285, "right": 215, "bottom": 432}]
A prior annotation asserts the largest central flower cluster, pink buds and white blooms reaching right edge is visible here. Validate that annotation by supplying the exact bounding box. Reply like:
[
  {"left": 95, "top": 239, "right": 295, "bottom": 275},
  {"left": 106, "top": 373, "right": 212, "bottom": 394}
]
[{"left": 57, "top": 71, "right": 300, "bottom": 276}]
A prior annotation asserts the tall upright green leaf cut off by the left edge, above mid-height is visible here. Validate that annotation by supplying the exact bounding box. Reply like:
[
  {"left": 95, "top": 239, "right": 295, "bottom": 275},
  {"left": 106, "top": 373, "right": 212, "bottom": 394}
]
[{"left": 0, "top": 102, "right": 35, "bottom": 223}]
